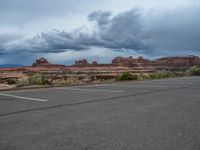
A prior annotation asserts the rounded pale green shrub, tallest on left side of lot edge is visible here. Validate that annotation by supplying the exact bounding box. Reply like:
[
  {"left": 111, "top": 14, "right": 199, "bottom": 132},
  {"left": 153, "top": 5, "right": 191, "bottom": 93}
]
[{"left": 29, "top": 73, "right": 47, "bottom": 85}]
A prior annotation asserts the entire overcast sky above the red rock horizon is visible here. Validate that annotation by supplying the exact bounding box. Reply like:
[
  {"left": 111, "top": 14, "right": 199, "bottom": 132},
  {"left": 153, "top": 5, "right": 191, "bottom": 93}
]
[{"left": 0, "top": 0, "right": 200, "bottom": 65}]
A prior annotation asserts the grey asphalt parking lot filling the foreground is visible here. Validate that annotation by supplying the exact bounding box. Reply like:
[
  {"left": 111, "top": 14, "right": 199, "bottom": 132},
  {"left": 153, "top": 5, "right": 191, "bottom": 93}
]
[{"left": 0, "top": 77, "right": 200, "bottom": 150}]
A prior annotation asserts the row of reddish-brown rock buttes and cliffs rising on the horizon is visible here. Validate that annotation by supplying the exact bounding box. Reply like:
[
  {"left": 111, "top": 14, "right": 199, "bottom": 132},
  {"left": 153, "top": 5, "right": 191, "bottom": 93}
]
[{"left": 32, "top": 55, "right": 200, "bottom": 68}]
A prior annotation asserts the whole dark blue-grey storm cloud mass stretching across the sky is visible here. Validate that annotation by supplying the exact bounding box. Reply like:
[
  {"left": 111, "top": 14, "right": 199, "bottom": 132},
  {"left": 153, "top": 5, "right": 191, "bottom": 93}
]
[{"left": 1, "top": 5, "right": 200, "bottom": 54}]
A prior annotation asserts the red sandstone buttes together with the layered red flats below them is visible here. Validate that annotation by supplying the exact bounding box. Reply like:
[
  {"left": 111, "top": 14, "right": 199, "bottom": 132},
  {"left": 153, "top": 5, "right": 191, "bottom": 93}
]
[{"left": 0, "top": 55, "right": 200, "bottom": 78}]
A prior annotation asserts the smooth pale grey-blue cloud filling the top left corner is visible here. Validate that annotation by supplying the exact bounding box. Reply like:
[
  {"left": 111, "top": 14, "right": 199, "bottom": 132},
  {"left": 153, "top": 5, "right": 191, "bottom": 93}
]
[{"left": 0, "top": 0, "right": 80, "bottom": 25}]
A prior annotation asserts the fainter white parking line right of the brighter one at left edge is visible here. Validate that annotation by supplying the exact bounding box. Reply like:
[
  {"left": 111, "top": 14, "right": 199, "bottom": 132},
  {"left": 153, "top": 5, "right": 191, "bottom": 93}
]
[{"left": 56, "top": 88, "right": 124, "bottom": 93}]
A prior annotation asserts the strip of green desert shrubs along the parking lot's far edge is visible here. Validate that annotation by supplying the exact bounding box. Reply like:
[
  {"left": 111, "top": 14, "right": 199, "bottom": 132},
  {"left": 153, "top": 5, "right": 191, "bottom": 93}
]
[{"left": 6, "top": 66, "right": 200, "bottom": 87}]
